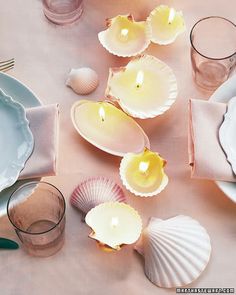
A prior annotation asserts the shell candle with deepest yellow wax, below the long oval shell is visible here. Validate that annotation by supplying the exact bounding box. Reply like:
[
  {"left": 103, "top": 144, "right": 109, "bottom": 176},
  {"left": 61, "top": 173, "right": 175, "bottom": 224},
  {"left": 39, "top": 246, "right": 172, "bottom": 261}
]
[{"left": 120, "top": 149, "right": 168, "bottom": 197}]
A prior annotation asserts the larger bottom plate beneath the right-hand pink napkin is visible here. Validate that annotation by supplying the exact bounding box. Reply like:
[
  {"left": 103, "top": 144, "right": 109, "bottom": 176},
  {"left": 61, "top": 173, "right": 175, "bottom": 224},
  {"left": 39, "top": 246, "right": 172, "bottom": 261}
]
[{"left": 209, "top": 75, "right": 236, "bottom": 202}]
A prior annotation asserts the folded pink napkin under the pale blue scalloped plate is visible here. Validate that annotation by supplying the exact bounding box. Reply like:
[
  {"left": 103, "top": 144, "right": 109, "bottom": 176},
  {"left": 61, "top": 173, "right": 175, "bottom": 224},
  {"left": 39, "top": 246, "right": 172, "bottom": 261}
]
[{"left": 20, "top": 104, "right": 59, "bottom": 179}]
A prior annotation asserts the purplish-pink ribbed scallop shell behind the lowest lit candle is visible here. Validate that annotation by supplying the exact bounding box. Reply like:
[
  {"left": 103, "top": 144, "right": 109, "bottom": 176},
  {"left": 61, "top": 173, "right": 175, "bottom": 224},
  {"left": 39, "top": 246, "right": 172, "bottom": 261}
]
[{"left": 70, "top": 177, "right": 126, "bottom": 214}]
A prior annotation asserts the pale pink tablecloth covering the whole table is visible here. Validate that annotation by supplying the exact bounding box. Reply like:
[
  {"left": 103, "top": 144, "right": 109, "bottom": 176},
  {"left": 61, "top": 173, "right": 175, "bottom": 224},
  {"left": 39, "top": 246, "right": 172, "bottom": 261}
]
[{"left": 0, "top": 0, "right": 236, "bottom": 295}]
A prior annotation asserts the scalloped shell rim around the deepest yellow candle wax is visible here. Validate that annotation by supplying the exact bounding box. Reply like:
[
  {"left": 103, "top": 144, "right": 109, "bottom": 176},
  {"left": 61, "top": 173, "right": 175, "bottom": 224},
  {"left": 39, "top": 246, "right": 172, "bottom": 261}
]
[{"left": 120, "top": 148, "right": 169, "bottom": 197}]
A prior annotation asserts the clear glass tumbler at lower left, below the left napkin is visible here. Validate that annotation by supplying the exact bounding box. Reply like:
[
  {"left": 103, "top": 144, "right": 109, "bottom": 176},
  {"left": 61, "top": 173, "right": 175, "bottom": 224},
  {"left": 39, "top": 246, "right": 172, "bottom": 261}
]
[{"left": 7, "top": 181, "right": 66, "bottom": 257}]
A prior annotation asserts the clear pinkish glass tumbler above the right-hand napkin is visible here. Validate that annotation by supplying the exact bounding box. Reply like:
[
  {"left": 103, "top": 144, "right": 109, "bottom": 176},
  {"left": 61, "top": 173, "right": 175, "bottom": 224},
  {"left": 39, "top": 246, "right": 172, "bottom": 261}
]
[{"left": 190, "top": 16, "right": 236, "bottom": 90}]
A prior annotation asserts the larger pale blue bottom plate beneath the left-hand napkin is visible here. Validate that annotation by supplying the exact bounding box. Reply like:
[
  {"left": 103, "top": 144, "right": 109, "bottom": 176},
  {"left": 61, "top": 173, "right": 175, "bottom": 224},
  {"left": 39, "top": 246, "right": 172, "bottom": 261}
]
[{"left": 0, "top": 72, "right": 42, "bottom": 216}]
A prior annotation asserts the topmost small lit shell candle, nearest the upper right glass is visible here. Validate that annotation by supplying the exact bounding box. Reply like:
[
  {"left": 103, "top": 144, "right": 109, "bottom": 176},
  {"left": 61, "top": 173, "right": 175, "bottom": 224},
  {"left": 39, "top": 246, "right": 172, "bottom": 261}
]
[{"left": 147, "top": 5, "right": 186, "bottom": 45}]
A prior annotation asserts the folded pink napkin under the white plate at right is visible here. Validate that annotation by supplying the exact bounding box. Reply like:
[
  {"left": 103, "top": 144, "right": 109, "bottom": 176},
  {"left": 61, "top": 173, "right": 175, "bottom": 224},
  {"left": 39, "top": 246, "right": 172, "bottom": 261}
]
[{"left": 188, "top": 99, "right": 236, "bottom": 182}]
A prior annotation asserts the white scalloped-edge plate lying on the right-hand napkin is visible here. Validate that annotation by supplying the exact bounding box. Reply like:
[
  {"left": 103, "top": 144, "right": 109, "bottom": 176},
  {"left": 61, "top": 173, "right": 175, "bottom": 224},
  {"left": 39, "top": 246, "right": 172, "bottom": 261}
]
[{"left": 219, "top": 97, "right": 236, "bottom": 174}]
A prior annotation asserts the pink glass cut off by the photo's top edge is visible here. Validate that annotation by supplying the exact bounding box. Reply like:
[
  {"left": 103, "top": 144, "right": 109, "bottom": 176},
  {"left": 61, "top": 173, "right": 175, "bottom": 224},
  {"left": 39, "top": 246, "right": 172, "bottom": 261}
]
[{"left": 42, "top": 0, "right": 83, "bottom": 25}]
